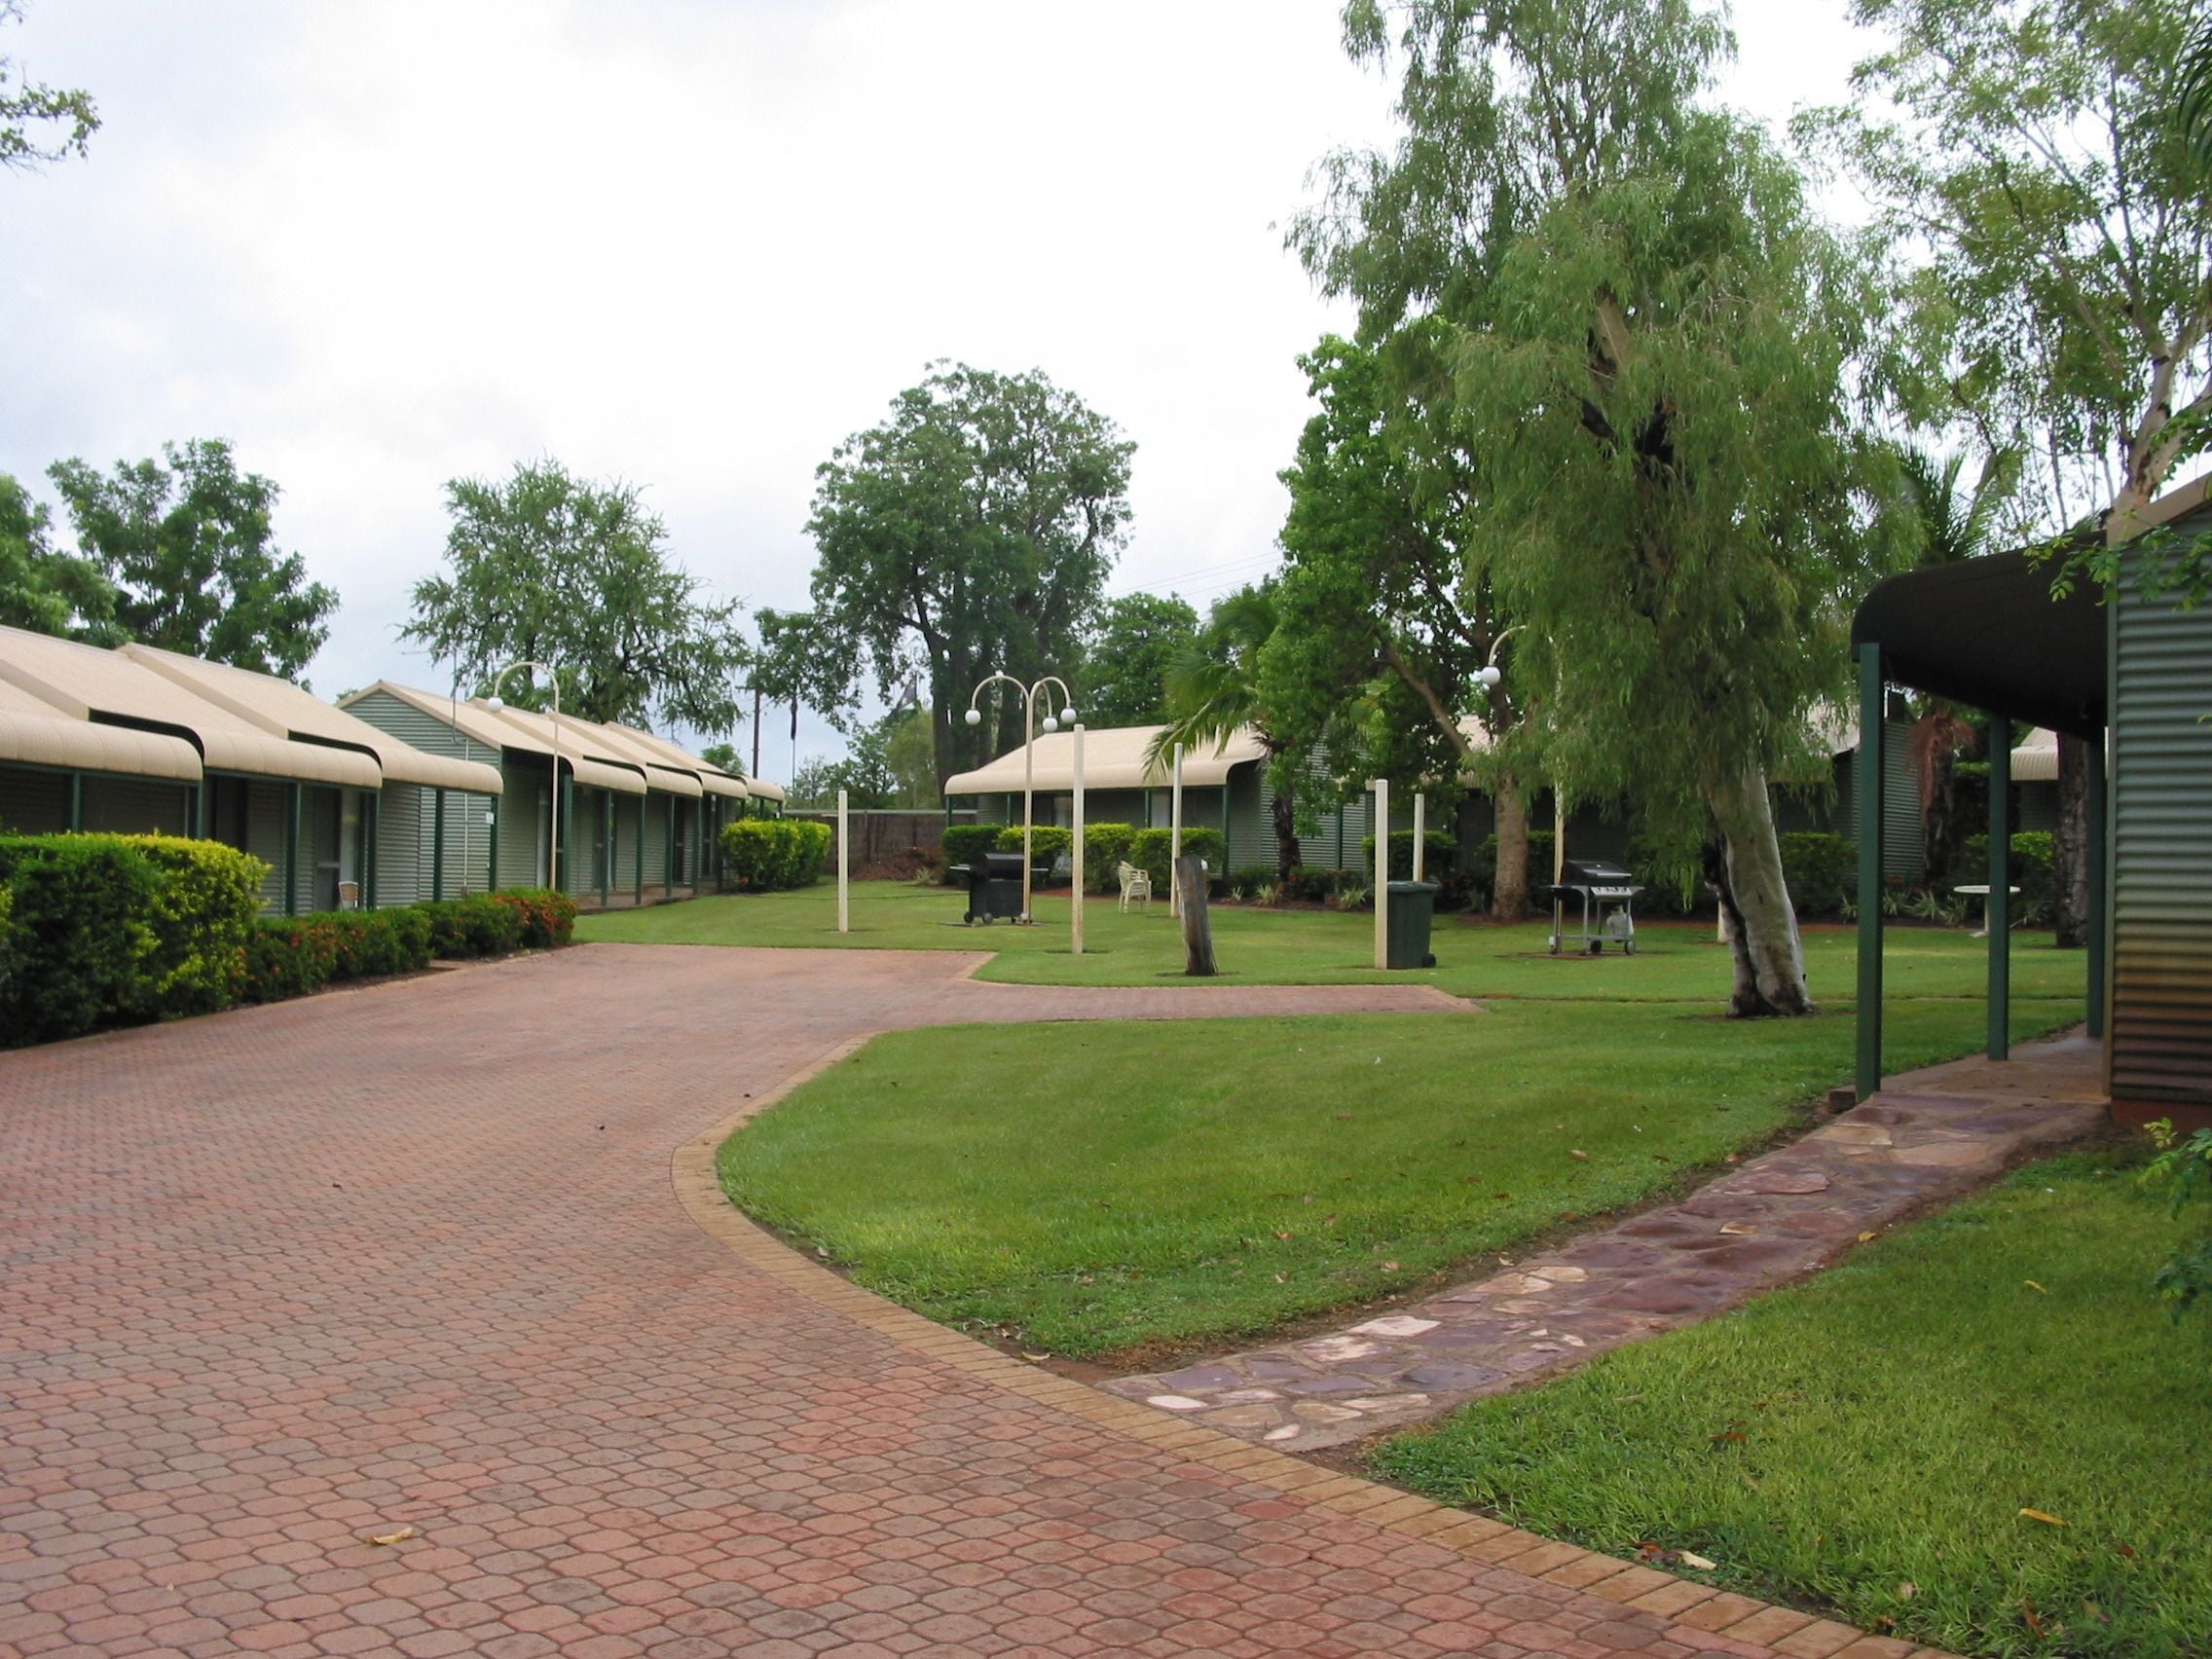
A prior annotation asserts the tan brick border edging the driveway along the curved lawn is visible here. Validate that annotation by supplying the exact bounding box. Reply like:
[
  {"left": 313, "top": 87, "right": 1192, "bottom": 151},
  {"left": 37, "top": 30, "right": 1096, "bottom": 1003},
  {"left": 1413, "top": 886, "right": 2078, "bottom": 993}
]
[{"left": 668, "top": 1039, "right": 1953, "bottom": 1659}]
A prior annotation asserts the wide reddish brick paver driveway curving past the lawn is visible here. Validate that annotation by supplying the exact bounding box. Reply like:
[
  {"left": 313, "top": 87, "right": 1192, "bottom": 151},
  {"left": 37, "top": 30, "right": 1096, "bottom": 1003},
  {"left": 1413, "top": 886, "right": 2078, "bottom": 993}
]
[{"left": 0, "top": 944, "right": 1787, "bottom": 1659}]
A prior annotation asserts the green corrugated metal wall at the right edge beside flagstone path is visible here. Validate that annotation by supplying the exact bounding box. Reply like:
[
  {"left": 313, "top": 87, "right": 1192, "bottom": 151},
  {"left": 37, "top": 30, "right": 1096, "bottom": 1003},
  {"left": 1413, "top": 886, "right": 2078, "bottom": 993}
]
[{"left": 2108, "top": 546, "right": 2212, "bottom": 1106}]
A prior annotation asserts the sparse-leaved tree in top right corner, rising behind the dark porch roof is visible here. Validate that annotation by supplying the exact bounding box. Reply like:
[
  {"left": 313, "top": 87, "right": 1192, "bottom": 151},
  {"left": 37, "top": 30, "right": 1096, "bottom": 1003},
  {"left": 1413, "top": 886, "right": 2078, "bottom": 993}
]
[{"left": 1807, "top": 0, "right": 2212, "bottom": 944}]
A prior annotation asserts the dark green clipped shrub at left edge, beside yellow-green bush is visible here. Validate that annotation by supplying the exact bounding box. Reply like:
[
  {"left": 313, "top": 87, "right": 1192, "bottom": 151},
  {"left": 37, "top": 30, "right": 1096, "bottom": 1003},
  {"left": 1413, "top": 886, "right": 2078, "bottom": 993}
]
[{"left": 0, "top": 836, "right": 162, "bottom": 1044}]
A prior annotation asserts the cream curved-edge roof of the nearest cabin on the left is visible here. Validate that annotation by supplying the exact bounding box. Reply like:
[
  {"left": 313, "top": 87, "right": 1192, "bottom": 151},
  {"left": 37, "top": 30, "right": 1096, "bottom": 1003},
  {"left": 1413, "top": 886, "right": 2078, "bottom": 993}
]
[{"left": 0, "top": 628, "right": 385, "bottom": 790}]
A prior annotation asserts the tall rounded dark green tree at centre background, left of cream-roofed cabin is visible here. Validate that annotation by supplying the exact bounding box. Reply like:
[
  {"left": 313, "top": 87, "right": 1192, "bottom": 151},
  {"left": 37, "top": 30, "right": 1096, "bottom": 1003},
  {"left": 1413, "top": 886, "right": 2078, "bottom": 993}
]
[{"left": 807, "top": 363, "right": 1135, "bottom": 786}]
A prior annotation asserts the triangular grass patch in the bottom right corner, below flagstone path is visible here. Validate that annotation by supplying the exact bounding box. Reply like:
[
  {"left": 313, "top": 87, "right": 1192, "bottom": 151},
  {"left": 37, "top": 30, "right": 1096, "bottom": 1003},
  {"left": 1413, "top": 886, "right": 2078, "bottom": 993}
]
[{"left": 1376, "top": 1155, "right": 2212, "bottom": 1659}]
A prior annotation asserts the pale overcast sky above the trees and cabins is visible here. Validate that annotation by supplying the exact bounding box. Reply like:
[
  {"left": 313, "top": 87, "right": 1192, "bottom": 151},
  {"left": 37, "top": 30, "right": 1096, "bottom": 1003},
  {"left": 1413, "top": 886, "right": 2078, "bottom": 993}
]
[{"left": 0, "top": 0, "right": 1856, "bottom": 776}]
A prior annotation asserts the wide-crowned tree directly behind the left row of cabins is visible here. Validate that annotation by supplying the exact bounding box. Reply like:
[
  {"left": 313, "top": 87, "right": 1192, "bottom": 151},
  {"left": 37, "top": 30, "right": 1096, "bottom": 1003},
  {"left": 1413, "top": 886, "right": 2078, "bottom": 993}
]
[{"left": 400, "top": 461, "right": 746, "bottom": 732}]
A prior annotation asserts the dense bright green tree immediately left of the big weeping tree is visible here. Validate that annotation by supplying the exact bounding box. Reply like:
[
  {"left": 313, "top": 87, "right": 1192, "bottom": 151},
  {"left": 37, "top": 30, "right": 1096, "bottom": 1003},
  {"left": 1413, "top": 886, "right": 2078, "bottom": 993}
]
[{"left": 1261, "top": 334, "right": 1530, "bottom": 918}]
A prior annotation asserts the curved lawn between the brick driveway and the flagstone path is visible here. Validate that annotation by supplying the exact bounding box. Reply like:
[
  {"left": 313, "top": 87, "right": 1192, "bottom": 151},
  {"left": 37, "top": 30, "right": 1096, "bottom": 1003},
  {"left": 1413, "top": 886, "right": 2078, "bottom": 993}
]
[{"left": 721, "top": 986, "right": 2077, "bottom": 1360}]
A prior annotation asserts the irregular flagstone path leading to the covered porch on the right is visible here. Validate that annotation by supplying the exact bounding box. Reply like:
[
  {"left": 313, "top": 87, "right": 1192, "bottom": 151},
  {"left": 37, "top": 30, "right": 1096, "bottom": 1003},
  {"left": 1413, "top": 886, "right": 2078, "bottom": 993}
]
[{"left": 1106, "top": 1038, "right": 2106, "bottom": 1451}]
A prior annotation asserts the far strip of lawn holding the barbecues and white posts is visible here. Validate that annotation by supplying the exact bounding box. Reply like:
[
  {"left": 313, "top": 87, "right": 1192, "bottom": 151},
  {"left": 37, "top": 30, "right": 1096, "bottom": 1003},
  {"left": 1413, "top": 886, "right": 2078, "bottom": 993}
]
[{"left": 577, "top": 880, "right": 2083, "bottom": 1007}]
